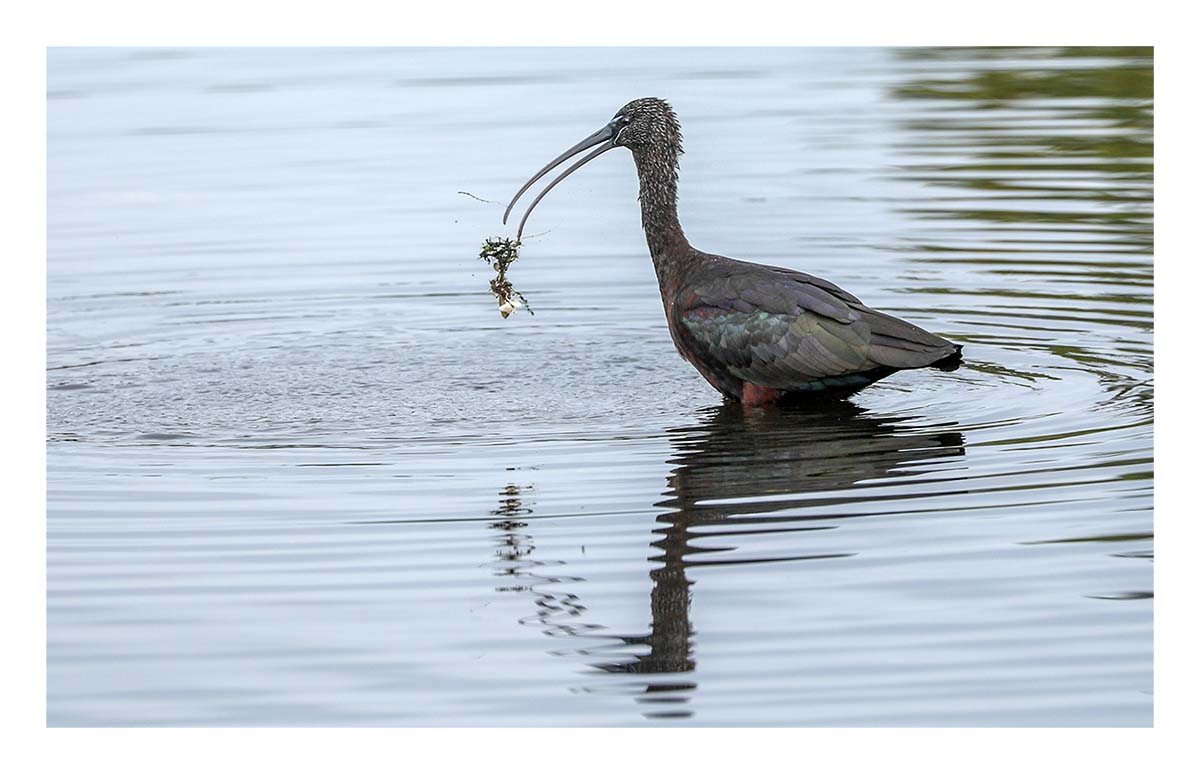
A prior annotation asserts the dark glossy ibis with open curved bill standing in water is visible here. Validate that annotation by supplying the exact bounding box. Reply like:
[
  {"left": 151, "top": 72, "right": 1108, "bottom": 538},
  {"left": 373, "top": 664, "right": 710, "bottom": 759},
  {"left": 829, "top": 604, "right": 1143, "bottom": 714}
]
[{"left": 504, "top": 97, "right": 962, "bottom": 406}]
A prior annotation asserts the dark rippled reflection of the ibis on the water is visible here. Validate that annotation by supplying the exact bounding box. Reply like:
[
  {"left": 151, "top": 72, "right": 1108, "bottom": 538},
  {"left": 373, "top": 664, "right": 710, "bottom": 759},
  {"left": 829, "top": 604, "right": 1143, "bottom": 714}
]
[{"left": 493, "top": 402, "right": 964, "bottom": 719}]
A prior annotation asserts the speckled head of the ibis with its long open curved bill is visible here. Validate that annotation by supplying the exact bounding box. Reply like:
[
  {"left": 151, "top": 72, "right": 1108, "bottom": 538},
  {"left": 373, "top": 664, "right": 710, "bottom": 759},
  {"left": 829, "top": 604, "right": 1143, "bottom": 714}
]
[{"left": 504, "top": 97, "right": 683, "bottom": 240}]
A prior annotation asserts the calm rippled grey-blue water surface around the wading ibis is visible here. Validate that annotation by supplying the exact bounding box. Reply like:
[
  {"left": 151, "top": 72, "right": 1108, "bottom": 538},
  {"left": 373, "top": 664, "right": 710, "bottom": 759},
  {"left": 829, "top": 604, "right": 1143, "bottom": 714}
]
[{"left": 47, "top": 49, "right": 1153, "bottom": 726}]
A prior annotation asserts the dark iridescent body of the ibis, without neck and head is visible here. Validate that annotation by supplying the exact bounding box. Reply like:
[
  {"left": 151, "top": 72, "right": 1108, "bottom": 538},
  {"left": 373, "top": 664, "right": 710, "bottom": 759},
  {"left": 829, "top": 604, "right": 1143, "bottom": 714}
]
[{"left": 660, "top": 247, "right": 958, "bottom": 404}]
